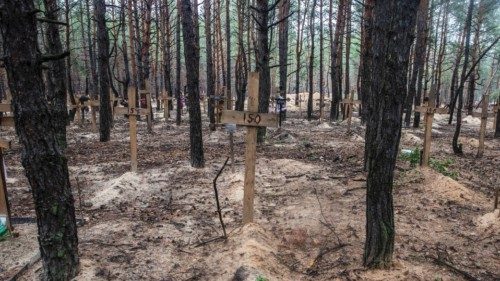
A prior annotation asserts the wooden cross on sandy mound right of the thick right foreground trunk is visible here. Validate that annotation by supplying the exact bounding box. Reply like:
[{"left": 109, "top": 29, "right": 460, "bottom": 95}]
[{"left": 415, "top": 90, "right": 448, "bottom": 166}]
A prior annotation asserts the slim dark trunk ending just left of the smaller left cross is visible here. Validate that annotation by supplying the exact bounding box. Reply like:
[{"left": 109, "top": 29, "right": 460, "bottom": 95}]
[{"left": 94, "top": 0, "right": 112, "bottom": 142}]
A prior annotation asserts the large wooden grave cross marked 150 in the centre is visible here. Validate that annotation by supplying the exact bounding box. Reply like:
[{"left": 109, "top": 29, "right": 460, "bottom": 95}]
[{"left": 221, "top": 72, "right": 278, "bottom": 224}]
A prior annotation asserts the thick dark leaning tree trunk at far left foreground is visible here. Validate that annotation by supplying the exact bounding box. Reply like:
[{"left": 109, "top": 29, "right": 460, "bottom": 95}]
[{"left": 0, "top": 0, "right": 79, "bottom": 280}]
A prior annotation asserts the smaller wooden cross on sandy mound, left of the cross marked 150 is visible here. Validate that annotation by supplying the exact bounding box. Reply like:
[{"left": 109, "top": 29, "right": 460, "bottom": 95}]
[{"left": 114, "top": 87, "right": 149, "bottom": 172}]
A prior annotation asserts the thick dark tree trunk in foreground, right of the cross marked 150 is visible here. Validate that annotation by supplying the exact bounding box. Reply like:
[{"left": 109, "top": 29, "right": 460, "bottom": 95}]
[{"left": 363, "top": 0, "right": 418, "bottom": 267}]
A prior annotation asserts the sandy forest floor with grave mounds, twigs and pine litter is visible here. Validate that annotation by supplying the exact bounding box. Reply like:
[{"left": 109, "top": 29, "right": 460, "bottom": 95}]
[{"left": 0, "top": 94, "right": 500, "bottom": 281}]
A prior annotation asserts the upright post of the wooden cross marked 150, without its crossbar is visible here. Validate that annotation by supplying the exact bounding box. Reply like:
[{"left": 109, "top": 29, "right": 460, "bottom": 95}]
[{"left": 243, "top": 72, "right": 259, "bottom": 224}]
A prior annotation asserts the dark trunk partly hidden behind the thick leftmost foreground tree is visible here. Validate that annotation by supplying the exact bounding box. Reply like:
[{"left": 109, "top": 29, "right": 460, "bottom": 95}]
[{"left": 44, "top": 0, "right": 69, "bottom": 150}]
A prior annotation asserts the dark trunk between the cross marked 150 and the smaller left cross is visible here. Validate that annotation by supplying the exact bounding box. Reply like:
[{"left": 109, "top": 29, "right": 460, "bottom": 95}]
[{"left": 180, "top": 0, "right": 205, "bottom": 168}]
